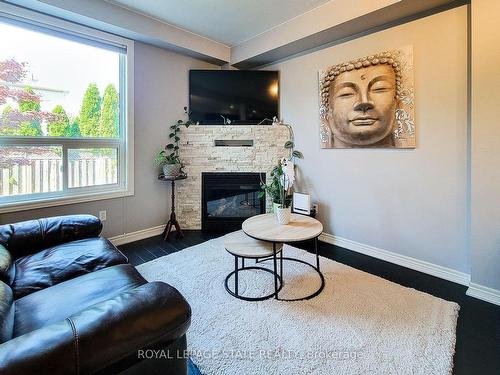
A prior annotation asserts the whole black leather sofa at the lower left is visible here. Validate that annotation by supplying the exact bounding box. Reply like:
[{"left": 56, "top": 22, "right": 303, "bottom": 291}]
[{"left": 0, "top": 215, "right": 191, "bottom": 375}]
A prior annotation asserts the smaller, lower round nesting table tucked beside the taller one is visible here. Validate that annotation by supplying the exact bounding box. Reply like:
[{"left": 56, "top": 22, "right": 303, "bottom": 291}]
[{"left": 224, "top": 231, "right": 283, "bottom": 301}]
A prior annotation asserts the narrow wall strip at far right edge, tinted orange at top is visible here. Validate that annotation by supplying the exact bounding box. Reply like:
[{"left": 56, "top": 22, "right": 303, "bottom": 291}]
[{"left": 471, "top": 0, "right": 500, "bottom": 292}]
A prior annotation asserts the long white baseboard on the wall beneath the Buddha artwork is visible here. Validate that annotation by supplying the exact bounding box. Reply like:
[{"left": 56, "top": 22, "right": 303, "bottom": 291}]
[{"left": 319, "top": 233, "right": 470, "bottom": 286}]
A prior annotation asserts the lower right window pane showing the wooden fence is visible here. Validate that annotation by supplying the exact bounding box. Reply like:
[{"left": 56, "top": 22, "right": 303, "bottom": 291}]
[{"left": 68, "top": 148, "right": 118, "bottom": 188}]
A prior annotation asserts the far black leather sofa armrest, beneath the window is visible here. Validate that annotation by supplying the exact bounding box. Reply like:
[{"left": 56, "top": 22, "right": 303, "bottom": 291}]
[{"left": 0, "top": 215, "right": 102, "bottom": 259}]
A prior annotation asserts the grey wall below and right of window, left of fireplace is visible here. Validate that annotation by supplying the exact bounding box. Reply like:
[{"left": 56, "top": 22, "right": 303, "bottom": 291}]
[{"left": 0, "top": 42, "right": 218, "bottom": 237}]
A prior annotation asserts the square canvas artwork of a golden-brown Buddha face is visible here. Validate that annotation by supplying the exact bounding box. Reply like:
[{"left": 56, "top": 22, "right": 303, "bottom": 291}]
[{"left": 319, "top": 46, "right": 415, "bottom": 148}]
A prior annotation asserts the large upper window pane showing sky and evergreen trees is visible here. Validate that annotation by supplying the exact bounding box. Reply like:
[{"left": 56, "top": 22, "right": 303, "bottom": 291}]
[{"left": 0, "top": 21, "right": 120, "bottom": 138}]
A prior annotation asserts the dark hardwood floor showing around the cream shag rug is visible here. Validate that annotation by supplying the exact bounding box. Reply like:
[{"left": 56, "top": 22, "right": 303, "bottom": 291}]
[{"left": 119, "top": 230, "right": 500, "bottom": 375}]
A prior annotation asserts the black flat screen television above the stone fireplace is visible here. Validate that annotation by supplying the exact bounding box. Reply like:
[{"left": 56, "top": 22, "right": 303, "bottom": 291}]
[{"left": 189, "top": 70, "right": 279, "bottom": 125}]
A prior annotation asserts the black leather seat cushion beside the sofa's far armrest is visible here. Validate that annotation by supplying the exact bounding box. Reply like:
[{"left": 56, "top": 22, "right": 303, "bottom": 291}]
[{"left": 9, "top": 237, "right": 128, "bottom": 299}]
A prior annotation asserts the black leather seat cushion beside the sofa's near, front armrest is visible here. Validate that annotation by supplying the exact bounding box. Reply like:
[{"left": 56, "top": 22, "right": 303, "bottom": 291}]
[{"left": 13, "top": 264, "right": 146, "bottom": 337}]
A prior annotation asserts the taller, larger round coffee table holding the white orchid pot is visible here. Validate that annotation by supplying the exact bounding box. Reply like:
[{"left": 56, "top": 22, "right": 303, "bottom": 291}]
[{"left": 242, "top": 214, "right": 325, "bottom": 301}]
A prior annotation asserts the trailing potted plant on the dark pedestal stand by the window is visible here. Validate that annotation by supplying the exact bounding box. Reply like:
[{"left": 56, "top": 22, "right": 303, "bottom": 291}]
[{"left": 155, "top": 107, "right": 194, "bottom": 177}]
